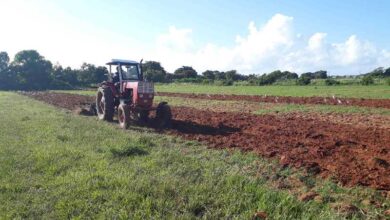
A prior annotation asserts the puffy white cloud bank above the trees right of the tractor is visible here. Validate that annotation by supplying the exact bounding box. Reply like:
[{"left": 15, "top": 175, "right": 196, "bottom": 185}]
[{"left": 151, "top": 14, "right": 390, "bottom": 74}]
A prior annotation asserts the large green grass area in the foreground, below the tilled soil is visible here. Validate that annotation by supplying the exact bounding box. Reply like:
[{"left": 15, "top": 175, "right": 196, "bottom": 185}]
[{"left": 0, "top": 92, "right": 386, "bottom": 219}]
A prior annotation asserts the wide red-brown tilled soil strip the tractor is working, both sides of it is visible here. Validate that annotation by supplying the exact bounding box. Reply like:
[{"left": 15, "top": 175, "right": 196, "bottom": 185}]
[{"left": 26, "top": 93, "right": 390, "bottom": 191}]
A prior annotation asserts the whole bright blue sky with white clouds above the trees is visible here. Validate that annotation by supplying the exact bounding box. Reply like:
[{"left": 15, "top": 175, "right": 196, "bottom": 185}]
[{"left": 0, "top": 0, "right": 390, "bottom": 75}]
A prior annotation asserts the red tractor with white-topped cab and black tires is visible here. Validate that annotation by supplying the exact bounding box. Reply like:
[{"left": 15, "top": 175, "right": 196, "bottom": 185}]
[{"left": 96, "top": 59, "right": 172, "bottom": 129}]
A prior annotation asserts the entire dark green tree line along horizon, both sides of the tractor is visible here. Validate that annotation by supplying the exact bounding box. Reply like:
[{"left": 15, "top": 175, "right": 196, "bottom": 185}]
[{"left": 0, "top": 50, "right": 390, "bottom": 90}]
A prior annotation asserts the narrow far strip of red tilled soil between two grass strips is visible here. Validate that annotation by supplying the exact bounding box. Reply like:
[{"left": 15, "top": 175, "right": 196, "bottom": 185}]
[{"left": 158, "top": 92, "right": 390, "bottom": 108}]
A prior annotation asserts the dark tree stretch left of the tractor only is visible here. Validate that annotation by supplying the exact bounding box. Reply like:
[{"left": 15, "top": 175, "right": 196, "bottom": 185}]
[{"left": 0, "top": 50, "right": 108, "bottom": 90}]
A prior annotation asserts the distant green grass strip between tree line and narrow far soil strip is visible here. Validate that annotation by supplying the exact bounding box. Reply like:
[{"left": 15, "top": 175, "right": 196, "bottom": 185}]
[{"left": 156, "top": 84, "right": 390, "bottom": 99}]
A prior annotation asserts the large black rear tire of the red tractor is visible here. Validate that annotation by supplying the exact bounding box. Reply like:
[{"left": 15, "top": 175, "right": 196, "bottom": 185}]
[{"left": 96, "top": 87, "right": 115, "bottom": 121}]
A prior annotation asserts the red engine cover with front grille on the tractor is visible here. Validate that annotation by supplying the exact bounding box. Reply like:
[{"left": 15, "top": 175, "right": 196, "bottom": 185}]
[{"left": 122, "top": 81, "right": 154, "bottom": 108}]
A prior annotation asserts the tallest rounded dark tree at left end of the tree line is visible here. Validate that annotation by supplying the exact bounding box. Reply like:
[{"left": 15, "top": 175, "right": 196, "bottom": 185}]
[{"left": 10, "top": 50, "right": 52, "bottom": 89}]
